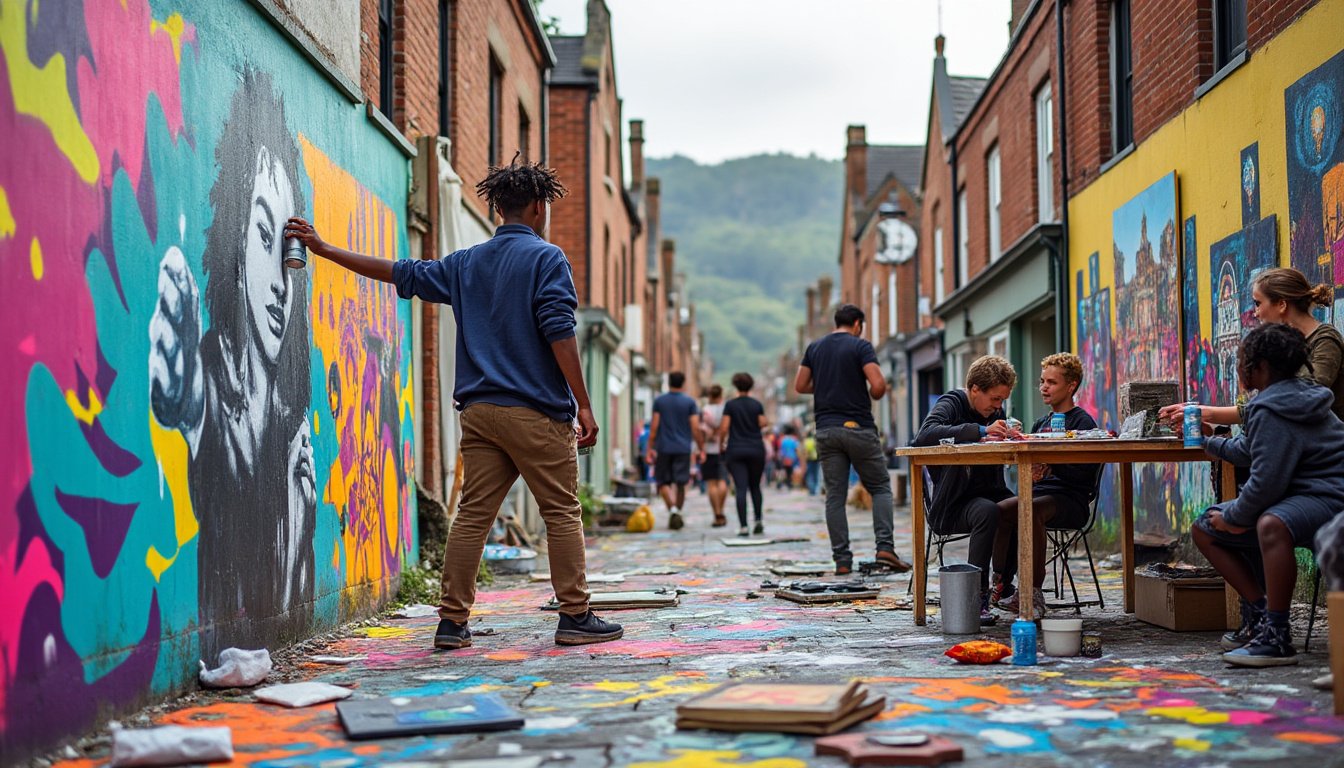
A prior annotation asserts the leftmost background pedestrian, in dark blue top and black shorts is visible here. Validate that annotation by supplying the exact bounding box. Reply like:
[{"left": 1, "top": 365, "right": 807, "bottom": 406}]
[{"left": 644, "top": 371, "right": 704, "bottom": 531}]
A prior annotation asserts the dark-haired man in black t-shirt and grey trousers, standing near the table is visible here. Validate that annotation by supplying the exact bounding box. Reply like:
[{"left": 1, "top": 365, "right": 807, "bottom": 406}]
[{"left": 793, "top": 304, "right": 910, "bottom": 574}]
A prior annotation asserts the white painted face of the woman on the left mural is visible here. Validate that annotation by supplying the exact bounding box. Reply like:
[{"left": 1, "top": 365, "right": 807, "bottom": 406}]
[{"left": 243, "top": 148, "right": 297, "bottom": 363}]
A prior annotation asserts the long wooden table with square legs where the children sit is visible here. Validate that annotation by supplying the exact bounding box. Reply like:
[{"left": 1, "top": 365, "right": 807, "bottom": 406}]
[{"left": 896, "top": 437, "right": 1236, "bottom": 627}]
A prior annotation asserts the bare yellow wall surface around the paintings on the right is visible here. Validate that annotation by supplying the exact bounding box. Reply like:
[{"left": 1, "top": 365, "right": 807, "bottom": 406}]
[{"left": 1068, "top": 0, "right": 1344, "bottom": 344}]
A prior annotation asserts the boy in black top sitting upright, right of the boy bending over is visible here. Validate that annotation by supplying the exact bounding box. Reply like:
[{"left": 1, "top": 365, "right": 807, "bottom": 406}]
[{"left": 989, "top": 352, "right": 1101, "bottom": 615}]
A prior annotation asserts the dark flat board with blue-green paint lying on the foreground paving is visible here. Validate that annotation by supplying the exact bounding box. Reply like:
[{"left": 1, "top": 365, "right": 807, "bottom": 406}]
[{"left": 336, "top": 694, "right": 523, "bottom": 738}]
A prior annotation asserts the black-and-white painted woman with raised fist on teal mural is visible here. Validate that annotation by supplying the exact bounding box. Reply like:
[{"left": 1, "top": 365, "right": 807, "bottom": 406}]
[{"left": 149, "top": 70, "right": 316, "bottom": 656}]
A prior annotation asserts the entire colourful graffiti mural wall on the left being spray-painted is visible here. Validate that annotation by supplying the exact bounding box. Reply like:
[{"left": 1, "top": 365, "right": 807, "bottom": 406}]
[{"left": 0, "top": 0, "right": 415, "bottom": 757}]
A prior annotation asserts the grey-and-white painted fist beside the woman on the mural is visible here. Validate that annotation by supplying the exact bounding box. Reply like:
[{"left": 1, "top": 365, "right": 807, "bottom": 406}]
[{"left": 149, "top": 246, "right": 206, "bottom": 448}]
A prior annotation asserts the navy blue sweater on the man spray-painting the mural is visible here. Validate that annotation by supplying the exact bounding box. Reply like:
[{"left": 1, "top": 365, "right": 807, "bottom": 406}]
[{"left": 392, "top": 225, "right": 578, "bottom": 421}]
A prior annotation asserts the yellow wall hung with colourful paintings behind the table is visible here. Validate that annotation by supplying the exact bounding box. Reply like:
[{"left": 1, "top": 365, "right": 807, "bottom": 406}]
[{"left": 1070, "top": 0, "right": 1344, "bottom": 537}]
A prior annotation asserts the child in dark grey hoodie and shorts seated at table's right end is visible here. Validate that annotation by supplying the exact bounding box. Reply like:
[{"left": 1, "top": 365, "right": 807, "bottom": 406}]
[{"left": 1191, "top": 323, "right": 1344, "bottom": 667}]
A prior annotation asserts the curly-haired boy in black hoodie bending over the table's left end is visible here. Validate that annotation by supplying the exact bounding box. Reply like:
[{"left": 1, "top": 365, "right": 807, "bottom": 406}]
[{"left": 913, "top": 355, "right": 1021, "bottom": 624}]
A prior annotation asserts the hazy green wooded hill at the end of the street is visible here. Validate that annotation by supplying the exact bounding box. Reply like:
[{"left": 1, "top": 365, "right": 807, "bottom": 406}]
[{"left": 648, "top": 155, "right": 844, "bottom": 381}]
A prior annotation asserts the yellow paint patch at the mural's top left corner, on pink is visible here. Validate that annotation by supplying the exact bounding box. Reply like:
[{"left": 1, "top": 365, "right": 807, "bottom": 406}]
[{"left": 0, "top": 0, "right": 98, "bottom": 184}]
